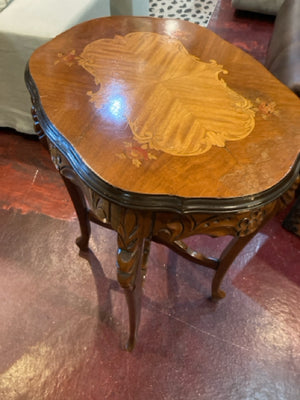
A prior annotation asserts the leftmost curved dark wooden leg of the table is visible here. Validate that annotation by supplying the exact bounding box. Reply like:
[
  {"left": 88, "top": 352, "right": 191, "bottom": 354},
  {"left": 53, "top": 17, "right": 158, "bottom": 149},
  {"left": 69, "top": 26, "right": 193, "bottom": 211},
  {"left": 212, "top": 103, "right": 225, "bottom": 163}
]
[{"left": 60, "top": 169, "right": 91, "bottom": 251}]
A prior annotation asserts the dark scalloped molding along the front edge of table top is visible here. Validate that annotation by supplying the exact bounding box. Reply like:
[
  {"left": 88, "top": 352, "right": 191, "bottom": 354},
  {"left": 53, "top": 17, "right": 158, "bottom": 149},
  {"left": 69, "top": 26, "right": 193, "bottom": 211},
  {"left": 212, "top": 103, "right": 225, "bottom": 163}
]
[{"left": 25, "top": 62, "right": 300, "bottom": 214}]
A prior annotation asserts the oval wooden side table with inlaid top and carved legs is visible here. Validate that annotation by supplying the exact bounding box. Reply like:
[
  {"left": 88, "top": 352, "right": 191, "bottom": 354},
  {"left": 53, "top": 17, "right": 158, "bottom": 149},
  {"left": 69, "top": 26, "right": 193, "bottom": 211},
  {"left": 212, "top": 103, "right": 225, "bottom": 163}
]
[{"left": 26, "top": 17, "right": 300, "bottom": 350}]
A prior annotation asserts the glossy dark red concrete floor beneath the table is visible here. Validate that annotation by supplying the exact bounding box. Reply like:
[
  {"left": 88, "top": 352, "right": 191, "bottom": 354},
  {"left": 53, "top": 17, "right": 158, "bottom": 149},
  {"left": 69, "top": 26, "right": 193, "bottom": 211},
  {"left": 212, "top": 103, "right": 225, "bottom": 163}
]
[{"left": 0, "top": 0, "right": 300, "bottom": 400}]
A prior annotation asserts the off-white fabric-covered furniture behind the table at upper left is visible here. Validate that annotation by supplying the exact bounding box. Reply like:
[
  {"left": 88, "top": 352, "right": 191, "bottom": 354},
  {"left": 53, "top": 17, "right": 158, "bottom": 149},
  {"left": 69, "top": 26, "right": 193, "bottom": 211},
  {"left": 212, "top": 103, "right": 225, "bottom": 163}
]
[{"left": 0, "top": 0, "right": 110, "bottom": 133}]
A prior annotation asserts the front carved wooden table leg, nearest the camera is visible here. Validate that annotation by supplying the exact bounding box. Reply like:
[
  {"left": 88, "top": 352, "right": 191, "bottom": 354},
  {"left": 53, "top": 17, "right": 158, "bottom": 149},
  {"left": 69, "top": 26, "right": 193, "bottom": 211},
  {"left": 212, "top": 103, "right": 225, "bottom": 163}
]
[{"left": 113, "top": 210, "right": 150, "bottom": 351}]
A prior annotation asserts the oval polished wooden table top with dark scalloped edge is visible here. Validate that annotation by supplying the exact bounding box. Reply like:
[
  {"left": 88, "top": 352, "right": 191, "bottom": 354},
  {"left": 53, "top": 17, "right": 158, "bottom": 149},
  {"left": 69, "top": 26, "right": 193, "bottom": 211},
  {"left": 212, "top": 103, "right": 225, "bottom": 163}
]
[{"left": 26, "top": 17, "right": 300, "bottom": 212}]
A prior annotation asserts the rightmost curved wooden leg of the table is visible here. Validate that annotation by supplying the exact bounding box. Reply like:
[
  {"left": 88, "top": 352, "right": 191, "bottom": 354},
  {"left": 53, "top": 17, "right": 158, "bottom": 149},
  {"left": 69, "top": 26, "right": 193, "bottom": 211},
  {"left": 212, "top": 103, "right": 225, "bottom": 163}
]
[{"left": 212, "top": 232, "right": 256, "bottom": 300}]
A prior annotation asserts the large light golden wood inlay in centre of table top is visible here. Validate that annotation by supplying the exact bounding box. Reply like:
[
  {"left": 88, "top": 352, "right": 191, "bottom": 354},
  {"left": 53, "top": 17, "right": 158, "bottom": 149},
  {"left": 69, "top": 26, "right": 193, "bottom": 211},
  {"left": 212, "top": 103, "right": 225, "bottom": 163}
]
[{"left": 77, "top": 32, "right": 255, "bottom": 156}]
